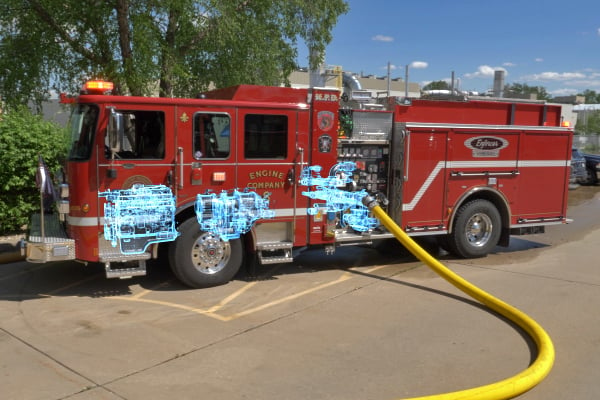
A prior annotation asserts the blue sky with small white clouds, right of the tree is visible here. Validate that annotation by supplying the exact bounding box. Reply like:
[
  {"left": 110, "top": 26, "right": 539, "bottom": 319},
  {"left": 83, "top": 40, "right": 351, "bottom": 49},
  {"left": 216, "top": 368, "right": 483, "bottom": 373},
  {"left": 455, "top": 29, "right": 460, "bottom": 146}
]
[{"left": 298, "top": 0, "right": 600, "bottom": 96}]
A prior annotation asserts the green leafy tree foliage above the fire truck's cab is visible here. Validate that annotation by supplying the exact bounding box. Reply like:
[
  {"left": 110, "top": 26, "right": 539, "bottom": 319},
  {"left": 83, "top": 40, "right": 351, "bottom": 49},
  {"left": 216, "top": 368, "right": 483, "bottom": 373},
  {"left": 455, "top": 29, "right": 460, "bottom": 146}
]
[{"left": 0, "top": 0, "right": 348, "bottom": 105}]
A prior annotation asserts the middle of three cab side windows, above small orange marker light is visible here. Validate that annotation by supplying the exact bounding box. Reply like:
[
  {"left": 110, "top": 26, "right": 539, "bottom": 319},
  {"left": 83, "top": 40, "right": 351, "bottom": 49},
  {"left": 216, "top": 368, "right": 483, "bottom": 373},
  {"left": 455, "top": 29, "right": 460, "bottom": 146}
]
[{"left": 193, "top": 113, "right": 231, "bottom": 160}]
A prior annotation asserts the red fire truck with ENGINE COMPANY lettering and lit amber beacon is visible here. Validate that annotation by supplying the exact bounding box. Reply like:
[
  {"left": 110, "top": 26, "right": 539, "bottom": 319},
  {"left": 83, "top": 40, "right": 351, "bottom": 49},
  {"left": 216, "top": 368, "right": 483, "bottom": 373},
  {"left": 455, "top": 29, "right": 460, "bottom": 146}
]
[{"left": 25, "top": 82, "right": 572, "bottom": 287}]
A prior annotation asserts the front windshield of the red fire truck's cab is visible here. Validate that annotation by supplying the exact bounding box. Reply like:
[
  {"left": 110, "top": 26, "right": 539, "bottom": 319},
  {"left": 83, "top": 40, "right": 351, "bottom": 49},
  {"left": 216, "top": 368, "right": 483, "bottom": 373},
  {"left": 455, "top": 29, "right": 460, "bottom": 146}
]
[{"left": 69, "top": 104, "right": 98, "bottom": 160}]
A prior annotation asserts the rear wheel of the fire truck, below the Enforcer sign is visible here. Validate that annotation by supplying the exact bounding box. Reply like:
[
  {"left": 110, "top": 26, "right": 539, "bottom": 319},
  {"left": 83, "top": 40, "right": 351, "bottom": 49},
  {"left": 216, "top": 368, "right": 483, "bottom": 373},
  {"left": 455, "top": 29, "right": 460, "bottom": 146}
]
[{"left": 444, "top": 199, "right": 502, "bottom": 258}]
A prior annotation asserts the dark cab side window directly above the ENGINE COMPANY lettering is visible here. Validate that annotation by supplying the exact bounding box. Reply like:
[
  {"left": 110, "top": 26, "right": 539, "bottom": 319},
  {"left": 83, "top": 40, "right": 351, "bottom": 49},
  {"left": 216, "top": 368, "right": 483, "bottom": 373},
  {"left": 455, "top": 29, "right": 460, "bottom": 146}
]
[{"left": 244, "top": 114, "right": 288, "bottom": 159}]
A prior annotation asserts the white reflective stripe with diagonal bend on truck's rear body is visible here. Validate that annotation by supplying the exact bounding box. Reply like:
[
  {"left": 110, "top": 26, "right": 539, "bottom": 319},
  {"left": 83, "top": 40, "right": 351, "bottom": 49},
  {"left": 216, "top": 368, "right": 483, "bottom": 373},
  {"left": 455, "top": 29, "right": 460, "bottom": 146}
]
[{"left": 402, "top": 160, "right": 570, "bottom": 211}]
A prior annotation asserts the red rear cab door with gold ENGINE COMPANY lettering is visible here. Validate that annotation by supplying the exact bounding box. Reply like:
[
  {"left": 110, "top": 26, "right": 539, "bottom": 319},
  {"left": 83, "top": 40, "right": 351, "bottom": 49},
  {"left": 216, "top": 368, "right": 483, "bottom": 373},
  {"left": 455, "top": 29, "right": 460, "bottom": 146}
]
[{"left": 237, "top": 108, "right": 307, "bottom": 247}]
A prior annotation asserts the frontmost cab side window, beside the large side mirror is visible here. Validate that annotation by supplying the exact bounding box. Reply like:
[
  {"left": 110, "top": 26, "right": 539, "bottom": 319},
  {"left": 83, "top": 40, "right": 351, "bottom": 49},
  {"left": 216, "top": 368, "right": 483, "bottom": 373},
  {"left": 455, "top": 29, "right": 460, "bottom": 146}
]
[{"left": 106, "top": 110, "right": 165, "bottom": 159}]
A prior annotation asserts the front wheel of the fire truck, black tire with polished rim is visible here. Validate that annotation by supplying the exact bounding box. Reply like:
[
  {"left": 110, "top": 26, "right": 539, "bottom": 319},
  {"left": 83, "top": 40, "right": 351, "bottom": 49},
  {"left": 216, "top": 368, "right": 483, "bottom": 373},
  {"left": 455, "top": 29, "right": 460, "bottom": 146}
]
[{"left": 169, "top": 218, "right": 243, "bottom": 288}]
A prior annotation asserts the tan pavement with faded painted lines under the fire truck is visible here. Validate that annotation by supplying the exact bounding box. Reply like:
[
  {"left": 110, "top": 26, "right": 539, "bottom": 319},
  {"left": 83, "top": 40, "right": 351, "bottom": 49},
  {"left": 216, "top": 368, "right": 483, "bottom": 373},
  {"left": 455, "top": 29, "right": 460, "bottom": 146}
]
[{"left": 0, "top": 188, "right": 600, "bottom": 400}]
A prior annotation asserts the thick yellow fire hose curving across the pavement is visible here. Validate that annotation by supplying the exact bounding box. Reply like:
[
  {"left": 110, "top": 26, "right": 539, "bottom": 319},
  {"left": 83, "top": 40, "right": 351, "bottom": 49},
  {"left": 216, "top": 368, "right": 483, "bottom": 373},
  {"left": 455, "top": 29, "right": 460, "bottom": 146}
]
[{"left": 363, "top": 196, "right": 554, "bottom": 400}]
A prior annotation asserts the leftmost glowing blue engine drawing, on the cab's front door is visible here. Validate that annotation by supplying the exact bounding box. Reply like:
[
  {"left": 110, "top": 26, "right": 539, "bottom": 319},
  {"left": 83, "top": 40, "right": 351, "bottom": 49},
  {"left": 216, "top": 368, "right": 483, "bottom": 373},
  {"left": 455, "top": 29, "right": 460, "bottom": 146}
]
[{"left": 98, "top": 184, "right": 179, "bottom": 254}]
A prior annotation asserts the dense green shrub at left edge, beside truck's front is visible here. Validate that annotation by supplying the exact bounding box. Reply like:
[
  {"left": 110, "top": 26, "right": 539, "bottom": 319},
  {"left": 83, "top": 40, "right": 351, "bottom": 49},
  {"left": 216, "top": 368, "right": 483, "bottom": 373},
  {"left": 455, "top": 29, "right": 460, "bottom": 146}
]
[{"left": 0, "top": 107, "right": 68, "bottom": 235}]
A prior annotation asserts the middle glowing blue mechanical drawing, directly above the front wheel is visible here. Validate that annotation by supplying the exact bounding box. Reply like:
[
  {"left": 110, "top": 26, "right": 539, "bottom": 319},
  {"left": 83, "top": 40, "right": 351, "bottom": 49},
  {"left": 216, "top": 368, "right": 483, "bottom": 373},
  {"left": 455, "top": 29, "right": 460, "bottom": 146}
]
[{"left": 195, "top": 189, "right": 275, "bottom": 241}]
